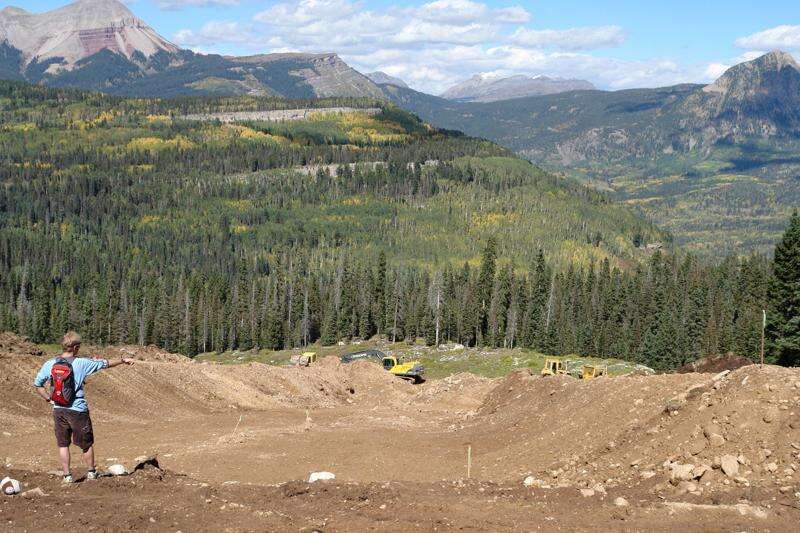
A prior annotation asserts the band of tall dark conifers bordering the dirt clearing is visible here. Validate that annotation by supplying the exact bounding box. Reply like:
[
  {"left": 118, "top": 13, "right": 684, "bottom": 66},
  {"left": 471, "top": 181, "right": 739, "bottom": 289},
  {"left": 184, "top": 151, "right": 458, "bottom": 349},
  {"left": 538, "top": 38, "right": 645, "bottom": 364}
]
[{"left": 0, "top": 211, "right": 800, "bottom": 370}]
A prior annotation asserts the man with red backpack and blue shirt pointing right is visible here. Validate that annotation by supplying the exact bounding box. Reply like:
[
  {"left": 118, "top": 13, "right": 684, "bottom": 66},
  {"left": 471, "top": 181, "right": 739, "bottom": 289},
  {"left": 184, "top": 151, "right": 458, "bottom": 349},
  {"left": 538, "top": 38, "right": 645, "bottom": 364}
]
[{"left": 33, "top": 331, "right": 133, "bottom": 483}]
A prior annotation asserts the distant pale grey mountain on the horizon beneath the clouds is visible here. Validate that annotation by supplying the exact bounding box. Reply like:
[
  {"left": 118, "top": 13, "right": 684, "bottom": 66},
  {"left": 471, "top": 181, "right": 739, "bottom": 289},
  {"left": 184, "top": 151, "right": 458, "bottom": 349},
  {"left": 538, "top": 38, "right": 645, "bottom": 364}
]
[{"left": 442, "top": 74, "right": 595, "bottom": 102}]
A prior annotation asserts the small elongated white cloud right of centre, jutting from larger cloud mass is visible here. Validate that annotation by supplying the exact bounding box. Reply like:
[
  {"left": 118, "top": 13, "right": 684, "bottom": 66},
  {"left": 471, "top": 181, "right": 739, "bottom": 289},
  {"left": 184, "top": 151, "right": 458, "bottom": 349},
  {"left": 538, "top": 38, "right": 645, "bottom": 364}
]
[{"left": 510, "top": 26, "right": 625, "bottom": 50}]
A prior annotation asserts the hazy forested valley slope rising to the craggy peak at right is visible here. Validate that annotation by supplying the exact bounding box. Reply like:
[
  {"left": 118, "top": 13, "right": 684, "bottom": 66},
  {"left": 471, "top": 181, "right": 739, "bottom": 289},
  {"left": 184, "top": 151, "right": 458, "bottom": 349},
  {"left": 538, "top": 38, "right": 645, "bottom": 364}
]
[{"left": 390, "top": 52, "right": 800, "bottom": 258}]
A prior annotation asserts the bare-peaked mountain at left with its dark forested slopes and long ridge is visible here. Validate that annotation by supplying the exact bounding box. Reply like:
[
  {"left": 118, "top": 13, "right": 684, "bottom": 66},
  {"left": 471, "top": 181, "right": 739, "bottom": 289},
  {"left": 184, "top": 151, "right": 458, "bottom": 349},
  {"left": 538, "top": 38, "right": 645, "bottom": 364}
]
[{"left": 0, "top": 0, "right": 383, "bottom": 98}]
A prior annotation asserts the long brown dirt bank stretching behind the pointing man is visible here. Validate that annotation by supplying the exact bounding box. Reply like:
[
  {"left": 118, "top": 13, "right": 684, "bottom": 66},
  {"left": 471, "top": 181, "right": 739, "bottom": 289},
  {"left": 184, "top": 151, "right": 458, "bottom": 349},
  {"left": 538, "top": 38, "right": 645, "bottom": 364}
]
[{"left": 0, "top": 354, "right": 413, "bottom": 428}]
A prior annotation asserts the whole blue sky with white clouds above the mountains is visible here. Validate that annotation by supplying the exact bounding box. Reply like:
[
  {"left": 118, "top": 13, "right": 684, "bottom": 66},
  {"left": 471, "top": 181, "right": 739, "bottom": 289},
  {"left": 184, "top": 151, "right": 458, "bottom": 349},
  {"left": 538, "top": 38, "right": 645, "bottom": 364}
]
[{"left": 14, "top": 0, "right": 800, "bottom": 93}]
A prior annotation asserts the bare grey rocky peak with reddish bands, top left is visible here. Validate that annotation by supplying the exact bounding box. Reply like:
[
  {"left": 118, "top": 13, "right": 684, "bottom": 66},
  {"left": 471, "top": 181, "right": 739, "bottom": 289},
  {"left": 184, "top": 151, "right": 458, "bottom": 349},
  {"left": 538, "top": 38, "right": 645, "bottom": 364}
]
[{"left": 0, "top": 0, "right": 178, "bottom": 73}]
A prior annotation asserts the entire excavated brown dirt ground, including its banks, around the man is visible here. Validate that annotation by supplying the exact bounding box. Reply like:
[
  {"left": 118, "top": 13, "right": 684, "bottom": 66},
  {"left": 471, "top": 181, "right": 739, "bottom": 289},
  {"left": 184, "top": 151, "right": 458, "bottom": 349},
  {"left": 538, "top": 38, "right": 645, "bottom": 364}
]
[{"left": 0, "top": 338, "right": 800, "bottom": 531}]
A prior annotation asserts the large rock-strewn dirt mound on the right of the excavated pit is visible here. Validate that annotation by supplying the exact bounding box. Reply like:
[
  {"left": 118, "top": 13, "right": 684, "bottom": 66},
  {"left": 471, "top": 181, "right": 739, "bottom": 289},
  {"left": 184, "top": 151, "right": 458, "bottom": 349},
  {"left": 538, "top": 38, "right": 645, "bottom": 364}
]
[{"left": 466, "top": 365, "right": 800, "bottom": 502}]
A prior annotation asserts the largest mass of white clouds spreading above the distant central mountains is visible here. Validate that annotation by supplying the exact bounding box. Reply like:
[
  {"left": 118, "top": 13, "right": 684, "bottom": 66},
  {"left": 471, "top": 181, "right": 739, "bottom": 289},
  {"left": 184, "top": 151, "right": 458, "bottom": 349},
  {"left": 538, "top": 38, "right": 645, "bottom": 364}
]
[{"left": 173, "top": 0, "right": 720, "bottom": 93}]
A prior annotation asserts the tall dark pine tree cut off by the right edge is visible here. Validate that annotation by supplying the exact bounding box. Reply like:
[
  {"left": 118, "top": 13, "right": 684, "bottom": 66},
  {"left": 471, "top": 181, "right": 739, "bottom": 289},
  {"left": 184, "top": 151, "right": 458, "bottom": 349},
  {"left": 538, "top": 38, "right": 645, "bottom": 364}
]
[{"left": 768, "top": 211, "right": 800, "bottom": 366}]
